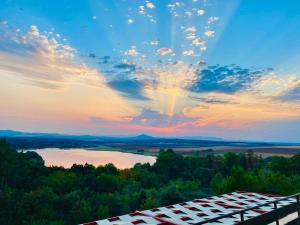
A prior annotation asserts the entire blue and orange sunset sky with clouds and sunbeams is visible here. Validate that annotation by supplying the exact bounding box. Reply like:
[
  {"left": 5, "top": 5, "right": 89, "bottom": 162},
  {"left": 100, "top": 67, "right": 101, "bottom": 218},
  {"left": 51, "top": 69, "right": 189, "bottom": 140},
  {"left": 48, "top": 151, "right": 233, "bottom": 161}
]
[{"left": 0, "top": 0, "right": 300, "bottom": 142}]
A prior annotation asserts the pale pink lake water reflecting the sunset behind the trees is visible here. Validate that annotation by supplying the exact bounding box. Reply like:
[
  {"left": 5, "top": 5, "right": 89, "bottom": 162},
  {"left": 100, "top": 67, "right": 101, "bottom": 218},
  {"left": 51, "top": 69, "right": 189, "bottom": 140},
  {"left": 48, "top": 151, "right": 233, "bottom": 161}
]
[{"left": 26, "top": 148, "right": 156, "bottom": 169}]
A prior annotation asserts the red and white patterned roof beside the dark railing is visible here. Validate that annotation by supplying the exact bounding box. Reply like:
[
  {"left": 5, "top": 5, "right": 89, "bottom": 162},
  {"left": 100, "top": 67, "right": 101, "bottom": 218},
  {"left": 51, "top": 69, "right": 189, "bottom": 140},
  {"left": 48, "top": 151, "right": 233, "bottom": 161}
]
[{"left": 83, "top": 191, "right": 296, "bottom": 225}]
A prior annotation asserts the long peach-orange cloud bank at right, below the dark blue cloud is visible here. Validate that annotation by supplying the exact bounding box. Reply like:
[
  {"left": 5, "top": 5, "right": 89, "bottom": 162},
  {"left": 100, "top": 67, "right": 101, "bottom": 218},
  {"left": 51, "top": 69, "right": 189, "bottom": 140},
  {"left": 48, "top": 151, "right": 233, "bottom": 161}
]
[{"left": 183, "top": 93, "right": 300, "bottom": 129}]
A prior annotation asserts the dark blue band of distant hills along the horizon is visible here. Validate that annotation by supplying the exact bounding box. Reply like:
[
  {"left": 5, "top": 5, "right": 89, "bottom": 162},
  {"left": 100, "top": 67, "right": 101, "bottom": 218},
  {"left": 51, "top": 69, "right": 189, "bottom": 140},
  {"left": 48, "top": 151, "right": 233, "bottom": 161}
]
[{"left": 0, "top": 130, "right": 296, "bottom": 149}]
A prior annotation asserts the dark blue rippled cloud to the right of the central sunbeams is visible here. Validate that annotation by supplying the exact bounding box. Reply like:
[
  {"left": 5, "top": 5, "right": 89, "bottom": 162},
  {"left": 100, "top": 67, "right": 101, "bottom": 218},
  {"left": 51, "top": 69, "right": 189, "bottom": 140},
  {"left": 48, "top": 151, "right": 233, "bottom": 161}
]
[{"left": 190, "top": 65, "right": 270, "bottom": 93}]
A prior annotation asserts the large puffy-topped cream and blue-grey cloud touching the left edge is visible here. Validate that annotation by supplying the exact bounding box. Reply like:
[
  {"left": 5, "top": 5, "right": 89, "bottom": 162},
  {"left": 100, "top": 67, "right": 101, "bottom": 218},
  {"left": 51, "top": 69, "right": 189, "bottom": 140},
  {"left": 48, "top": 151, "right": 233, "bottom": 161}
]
[{"left": 0, "top": 25, "right": 103, "bottom": 89}]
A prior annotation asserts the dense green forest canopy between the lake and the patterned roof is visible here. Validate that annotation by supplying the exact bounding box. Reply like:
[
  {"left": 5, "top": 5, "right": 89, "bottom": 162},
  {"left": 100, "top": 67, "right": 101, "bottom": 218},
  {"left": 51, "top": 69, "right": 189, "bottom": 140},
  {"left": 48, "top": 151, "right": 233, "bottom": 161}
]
[{"left": 0, "top": 140, "right": 300, "bottom": 225}]
